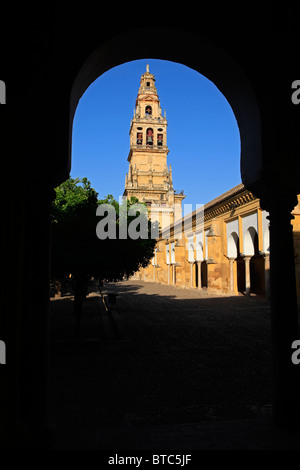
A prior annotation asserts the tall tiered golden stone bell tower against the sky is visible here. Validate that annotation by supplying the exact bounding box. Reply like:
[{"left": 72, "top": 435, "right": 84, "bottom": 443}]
[{"left": 123, "top": 65, "right": 185, "bottom": 229}]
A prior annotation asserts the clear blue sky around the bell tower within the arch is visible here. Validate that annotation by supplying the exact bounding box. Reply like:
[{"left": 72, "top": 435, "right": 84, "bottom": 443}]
[{"left": 71, "top": 59, "right": 241, "bottom": 210}]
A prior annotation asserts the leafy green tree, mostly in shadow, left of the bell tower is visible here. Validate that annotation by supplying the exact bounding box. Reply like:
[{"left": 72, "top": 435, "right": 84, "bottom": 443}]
[{"left": 51, "top": 178, "right": 156, "bottom": 327}]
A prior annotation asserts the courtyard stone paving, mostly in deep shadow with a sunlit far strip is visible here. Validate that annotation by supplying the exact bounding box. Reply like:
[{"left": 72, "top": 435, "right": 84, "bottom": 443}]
[{"left": 49, "top": 281, "right": 300, "bottom": 450}]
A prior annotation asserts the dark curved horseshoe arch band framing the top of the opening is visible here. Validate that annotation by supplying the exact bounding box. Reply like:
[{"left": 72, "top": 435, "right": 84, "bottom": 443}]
[{"left": 68, "top": 28, "right": 262, "bottom": 191}]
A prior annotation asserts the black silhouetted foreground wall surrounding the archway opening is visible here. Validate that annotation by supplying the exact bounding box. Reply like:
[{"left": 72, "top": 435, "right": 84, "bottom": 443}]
[{"left": 0, "top": 2, "right": 300, "bottom": 448}]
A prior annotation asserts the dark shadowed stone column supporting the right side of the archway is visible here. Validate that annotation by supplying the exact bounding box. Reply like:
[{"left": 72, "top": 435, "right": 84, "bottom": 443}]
[{"left": 268, "top": 200, "right": 300, "bottom": 427}]
